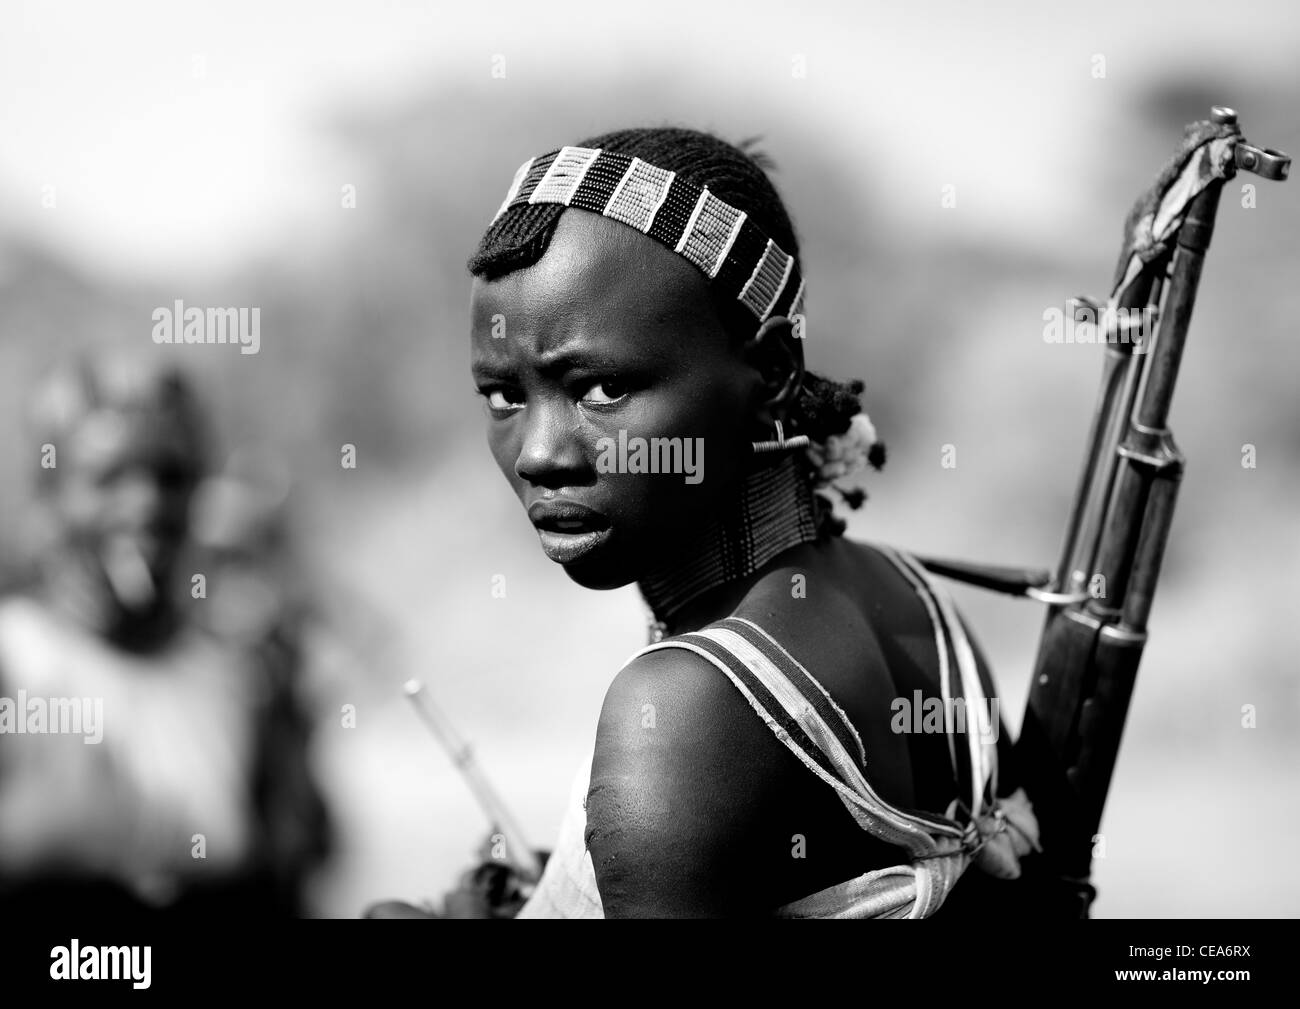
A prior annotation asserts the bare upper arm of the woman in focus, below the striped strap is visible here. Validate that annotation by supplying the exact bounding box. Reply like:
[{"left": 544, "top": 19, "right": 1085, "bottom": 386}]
[{"left": 586, "top": 649, "right": 780, "bottom": 918}]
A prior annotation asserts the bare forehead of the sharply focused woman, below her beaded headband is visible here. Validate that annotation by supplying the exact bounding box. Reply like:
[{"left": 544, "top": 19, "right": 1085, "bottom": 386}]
[{"left": 471, "top": 208, "right": 720, "bottom": 363}]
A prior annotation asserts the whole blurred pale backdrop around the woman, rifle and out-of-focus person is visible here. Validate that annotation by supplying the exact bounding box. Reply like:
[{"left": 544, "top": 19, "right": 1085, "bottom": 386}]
[{"left": 0, "top": 0, "right": 1300, "bottom": 917}]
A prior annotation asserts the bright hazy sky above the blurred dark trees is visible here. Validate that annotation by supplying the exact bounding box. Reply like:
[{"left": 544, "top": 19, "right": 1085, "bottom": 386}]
[{"left": 0, "top": 0, "right": 1300, "bottom": 273}]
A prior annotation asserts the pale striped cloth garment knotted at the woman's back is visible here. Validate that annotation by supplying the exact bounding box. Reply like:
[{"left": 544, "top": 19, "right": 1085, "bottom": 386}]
[{"left": 519, "top": 546, "right": 1037, "bottom": 918}]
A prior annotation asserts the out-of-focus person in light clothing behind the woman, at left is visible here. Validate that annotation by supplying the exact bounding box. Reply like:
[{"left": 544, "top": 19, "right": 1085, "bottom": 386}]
[{"left": 0, "top": 356, "right": 329, "bottom": 917}]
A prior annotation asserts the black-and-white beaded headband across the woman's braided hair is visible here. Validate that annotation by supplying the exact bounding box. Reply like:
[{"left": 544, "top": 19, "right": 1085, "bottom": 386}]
[{"left": 493, "top": 147, "right": 803, "bottom": 322}]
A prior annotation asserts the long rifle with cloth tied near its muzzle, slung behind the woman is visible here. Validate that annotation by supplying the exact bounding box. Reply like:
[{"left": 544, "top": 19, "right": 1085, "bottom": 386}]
[{"left": 918, "top": 105, "right": 1291, "bottom": 918}]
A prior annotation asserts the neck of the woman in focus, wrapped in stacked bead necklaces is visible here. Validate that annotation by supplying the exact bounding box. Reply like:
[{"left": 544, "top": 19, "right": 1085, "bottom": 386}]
[{"left": 637, "top": 455, "right": 818, "bottom": 641}]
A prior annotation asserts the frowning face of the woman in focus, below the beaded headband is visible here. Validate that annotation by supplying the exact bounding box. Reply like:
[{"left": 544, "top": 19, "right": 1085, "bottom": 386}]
[{"left": 471, "top": 209, "right": 766, "bottom": 589}]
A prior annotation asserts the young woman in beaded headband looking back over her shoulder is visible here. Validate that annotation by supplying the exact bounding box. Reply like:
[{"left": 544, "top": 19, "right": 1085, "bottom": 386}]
[{"left": 469, "top": 129, "right": 1036, "bottom": 918}]
